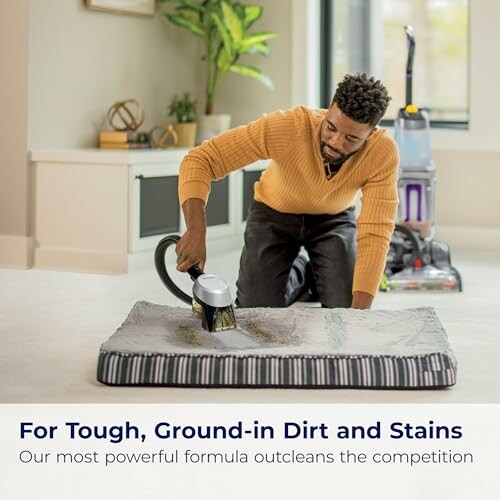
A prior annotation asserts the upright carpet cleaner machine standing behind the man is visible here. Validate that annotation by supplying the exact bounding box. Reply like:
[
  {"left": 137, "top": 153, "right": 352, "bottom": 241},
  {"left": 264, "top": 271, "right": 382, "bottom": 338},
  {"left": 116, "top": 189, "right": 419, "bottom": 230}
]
[{"left": 380, "top": 26, "right": 462, "bottom": 291}]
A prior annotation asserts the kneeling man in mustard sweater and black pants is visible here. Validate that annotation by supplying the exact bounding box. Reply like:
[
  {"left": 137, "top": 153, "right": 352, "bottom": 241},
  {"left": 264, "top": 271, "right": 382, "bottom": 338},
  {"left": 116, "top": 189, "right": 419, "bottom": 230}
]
[{"left": 176, "top": 74, "right": 399, "bottom": 309}]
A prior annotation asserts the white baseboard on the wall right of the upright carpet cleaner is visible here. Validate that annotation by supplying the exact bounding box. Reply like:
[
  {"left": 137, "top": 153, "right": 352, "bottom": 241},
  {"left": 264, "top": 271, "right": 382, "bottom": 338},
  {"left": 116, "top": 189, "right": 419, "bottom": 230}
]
[{"left": 436, "top": 226, "right": 500, "bottom": 252}]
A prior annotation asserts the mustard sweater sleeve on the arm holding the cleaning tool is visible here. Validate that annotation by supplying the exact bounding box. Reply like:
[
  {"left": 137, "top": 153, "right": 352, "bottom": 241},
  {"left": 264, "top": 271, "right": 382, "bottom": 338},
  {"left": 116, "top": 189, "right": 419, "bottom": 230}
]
[{"left": 179, "top": 108, "right": 301, "bottom": 205}]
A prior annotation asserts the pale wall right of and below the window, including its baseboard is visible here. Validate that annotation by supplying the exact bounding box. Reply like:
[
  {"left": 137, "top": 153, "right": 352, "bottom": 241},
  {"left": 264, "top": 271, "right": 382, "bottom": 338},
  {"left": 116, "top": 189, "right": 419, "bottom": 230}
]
[{"left": 432, "top": 0, "right": 500, "bottom": 250}]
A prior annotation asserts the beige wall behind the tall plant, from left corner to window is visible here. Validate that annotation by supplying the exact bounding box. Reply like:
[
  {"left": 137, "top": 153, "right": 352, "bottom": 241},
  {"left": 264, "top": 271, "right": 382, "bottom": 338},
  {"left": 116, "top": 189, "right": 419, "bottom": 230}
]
[{"left": 29, "top": 0, "right": 292, "bottom": 149}]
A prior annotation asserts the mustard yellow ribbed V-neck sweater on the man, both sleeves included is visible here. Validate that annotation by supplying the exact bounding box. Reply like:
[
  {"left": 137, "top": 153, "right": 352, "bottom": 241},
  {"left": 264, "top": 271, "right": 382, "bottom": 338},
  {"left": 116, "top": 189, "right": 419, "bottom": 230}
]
[{"left": 179, "top": 107, "right": 399, "bottom": 295}]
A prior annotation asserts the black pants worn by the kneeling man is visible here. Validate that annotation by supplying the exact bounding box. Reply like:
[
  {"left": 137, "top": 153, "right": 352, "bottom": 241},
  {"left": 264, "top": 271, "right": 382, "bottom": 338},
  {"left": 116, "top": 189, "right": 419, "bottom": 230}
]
[{"left": 236, "top": 201, "right": 356, "bottom": 307}]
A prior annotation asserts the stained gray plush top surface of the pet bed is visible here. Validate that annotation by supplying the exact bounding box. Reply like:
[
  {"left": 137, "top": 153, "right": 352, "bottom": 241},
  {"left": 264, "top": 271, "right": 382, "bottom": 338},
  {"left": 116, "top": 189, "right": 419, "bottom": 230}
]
[{"left": 101, "top": 301, "right": 453, "bottom": 356}]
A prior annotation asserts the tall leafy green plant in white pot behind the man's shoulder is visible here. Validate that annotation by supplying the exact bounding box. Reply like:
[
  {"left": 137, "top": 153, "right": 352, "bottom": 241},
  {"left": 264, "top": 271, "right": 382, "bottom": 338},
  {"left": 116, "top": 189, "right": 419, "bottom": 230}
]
[{"left": 157, "top": 0, "right": 277, "bottom": 142}]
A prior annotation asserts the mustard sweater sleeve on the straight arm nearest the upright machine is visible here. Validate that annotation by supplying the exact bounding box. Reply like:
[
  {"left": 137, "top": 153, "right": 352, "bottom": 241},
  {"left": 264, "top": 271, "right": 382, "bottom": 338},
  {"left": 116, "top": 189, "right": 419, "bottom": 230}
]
[{"left": 353, "top": 139, "right": 399, "bottom": 295}]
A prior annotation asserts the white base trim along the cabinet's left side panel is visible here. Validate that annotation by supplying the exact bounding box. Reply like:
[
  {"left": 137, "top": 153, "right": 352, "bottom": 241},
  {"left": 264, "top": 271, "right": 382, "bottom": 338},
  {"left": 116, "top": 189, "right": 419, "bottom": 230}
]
[{"left": 34, "top": 248, "right": 128, "bottom": 274}]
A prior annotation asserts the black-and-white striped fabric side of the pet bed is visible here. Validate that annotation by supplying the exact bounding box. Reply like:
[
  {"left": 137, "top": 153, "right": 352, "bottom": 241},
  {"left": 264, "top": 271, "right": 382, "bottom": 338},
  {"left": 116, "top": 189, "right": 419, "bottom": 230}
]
[{"left": 97, "top": 351, "right": 456, "bottom": 389}]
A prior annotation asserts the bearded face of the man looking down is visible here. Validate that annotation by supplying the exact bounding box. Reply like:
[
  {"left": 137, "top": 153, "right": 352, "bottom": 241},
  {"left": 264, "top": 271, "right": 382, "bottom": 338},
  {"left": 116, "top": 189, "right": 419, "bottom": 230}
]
[{"left": 321, "top": 103, "right": 373, "bottom": 163}]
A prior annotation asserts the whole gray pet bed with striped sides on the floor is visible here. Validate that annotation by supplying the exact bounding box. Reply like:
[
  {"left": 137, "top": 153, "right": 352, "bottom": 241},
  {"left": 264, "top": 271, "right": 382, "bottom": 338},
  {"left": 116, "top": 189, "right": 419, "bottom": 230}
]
[{"left": 97, "top": 301, "right": 456, "bottom": 389}]
